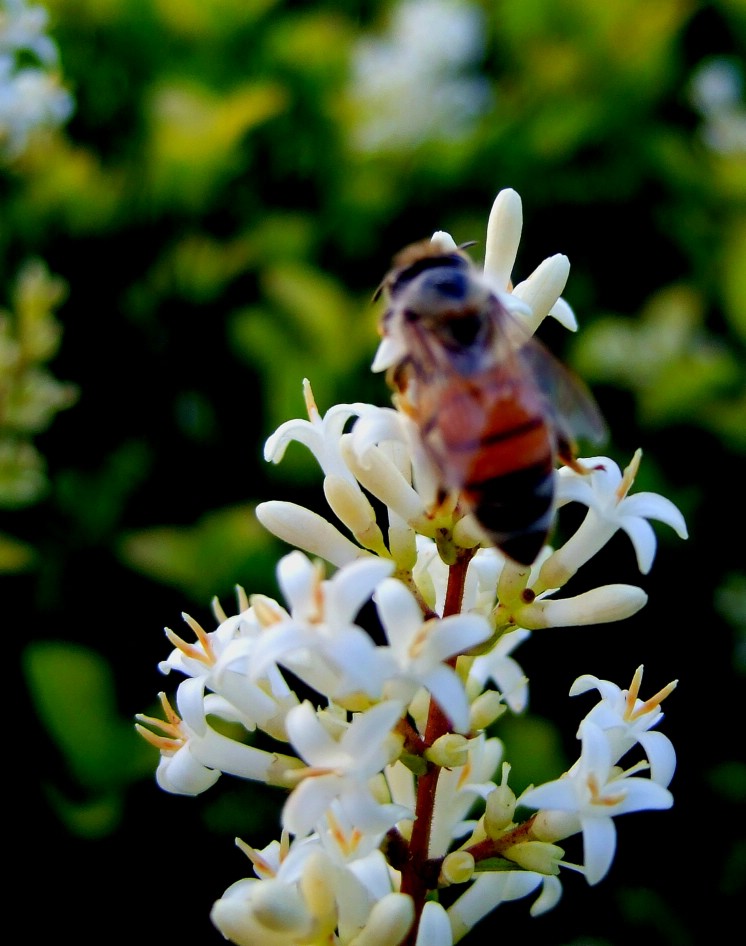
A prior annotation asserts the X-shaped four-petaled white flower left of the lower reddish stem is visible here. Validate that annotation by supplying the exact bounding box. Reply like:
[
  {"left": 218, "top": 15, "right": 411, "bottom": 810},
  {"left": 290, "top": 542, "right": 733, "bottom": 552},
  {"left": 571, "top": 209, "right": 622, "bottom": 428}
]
[{"left": 282, "top": 700, "right": 411, "bottom": 836}]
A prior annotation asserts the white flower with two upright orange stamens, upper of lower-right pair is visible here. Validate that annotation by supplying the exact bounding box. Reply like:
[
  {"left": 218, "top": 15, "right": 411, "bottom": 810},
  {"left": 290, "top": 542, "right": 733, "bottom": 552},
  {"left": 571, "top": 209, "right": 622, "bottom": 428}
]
[{"left": 570, "top": 667, "right": 676, "bottom": 787}]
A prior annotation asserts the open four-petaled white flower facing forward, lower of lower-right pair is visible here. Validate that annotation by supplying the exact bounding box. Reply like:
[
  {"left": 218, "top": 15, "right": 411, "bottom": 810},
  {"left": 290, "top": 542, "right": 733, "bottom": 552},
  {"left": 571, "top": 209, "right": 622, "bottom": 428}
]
[{"left": 520, "top": 719, "right": 673, "bottom": 884}]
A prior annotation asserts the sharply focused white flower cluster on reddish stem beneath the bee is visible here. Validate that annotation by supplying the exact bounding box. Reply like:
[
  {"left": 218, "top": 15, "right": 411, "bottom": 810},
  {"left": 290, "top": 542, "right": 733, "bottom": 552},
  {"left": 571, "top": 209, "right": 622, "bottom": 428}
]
[{"left": 139, "top": 191, "right": 686, "bottom": 946}]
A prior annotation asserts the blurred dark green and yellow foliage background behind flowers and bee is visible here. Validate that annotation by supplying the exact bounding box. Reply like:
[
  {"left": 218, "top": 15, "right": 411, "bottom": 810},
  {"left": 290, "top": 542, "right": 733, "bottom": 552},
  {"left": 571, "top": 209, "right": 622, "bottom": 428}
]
[{"left": 7, "top": 0, "right": 746, "bottom": 946}]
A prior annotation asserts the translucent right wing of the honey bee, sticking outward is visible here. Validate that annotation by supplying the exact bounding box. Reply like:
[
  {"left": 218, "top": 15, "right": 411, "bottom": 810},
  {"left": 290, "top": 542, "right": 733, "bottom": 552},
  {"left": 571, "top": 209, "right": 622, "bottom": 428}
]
[{"left": 515, "top": 337, "right": 607, "bottom": 445}]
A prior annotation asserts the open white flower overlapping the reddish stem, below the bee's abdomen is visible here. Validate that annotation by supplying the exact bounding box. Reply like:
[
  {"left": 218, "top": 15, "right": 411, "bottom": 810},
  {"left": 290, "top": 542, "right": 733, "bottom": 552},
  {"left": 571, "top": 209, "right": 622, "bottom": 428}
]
[{"left": 373, "top": 578, "right": 492, "bottom": 732}]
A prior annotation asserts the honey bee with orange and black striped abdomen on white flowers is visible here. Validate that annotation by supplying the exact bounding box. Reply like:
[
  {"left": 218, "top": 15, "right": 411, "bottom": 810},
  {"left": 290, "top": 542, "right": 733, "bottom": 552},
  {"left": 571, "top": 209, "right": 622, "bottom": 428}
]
[{"left": 376, "top": 240, "right": 605, "bottom": 566}]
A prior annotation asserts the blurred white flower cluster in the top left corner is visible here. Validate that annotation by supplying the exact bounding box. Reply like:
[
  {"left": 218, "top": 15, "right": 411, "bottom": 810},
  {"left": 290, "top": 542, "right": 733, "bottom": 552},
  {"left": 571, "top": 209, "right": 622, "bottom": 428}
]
[{"left": 0, "top": 0, "right": 73, "bottom": 160}]
